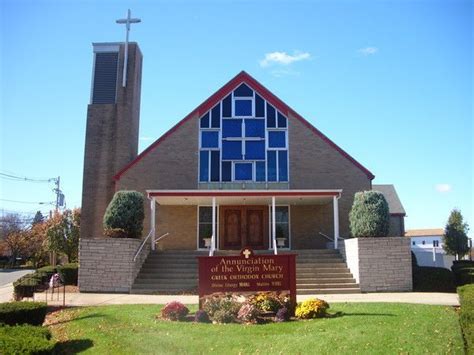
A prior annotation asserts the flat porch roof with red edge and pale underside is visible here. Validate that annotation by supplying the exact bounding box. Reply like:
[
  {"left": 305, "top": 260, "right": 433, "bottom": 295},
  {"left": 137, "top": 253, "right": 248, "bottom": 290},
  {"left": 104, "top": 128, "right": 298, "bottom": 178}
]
[{"left": 147, "top": 189, "right": 342, "bottom": 205}]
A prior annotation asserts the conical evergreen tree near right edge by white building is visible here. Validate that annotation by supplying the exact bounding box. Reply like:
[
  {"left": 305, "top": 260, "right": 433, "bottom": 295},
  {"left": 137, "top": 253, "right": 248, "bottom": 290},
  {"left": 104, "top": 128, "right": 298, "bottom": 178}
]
[{"left": 443, "top": 209, "right": 469, "bottom": 260}]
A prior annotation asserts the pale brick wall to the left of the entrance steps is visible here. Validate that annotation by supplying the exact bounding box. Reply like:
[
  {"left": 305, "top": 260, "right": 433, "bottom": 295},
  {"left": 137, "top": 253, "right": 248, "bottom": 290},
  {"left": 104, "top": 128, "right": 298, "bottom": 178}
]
[{"left": 79, "top": 238, "right": 150, "bottom": 293}]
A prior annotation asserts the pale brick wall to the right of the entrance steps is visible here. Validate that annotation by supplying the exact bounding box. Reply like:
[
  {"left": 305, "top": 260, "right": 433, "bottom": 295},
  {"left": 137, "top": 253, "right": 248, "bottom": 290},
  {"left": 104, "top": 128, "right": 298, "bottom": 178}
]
[{"left": 340, "top": 237, "right": 413, "bottom": 292}]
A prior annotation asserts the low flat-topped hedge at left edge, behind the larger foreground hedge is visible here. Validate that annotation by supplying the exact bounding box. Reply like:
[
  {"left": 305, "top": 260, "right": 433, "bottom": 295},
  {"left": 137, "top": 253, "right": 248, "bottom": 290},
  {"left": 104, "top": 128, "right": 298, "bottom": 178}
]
[{"left": 0, "top": 302, "right": 47, "bottom": 325}]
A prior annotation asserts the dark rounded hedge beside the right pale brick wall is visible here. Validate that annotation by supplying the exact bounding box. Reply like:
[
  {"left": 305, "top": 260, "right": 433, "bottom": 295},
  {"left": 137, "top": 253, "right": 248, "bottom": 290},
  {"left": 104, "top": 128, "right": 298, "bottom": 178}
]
[{"left": 413, "top": 266, "right": 456, "bottom": 292}]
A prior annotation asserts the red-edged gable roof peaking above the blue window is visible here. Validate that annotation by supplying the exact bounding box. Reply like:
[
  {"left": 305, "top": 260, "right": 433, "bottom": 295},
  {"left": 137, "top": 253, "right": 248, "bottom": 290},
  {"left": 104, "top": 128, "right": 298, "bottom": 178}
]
[{"left": 114, "top": 71, "right": 375, "bottom": 181}]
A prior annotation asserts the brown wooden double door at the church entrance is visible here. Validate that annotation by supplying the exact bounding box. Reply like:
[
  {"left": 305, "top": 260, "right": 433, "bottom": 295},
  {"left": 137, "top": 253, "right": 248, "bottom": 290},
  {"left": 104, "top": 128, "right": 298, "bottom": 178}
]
[{"left": 219, "top": 206, "right": 268, "bottom": 250}]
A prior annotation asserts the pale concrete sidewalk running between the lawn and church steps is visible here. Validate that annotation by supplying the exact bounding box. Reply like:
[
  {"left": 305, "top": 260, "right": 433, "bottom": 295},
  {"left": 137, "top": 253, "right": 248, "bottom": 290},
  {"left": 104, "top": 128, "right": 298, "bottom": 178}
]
[{"left": 25, "top": 292, "right": 459, "bottom": 306}]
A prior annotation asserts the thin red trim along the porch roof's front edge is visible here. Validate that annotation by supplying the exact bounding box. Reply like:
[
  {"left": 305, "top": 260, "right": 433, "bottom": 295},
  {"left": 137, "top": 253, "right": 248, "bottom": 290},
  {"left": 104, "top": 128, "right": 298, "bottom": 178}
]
[{"left": 148, "top": 190, "right": 339, "bottom": 197}]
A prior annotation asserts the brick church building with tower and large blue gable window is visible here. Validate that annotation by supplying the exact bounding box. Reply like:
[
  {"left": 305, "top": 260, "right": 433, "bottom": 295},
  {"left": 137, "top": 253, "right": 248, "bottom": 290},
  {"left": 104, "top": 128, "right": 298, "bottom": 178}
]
[{"left": 79, "top": 43, "right": 405, "bottom": 292}]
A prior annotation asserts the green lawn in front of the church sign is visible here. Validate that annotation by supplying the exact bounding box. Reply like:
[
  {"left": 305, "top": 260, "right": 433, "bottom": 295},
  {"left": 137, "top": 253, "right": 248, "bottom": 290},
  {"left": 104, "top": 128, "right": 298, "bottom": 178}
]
[{"left": 50, "top": 303, "right": 464, "bottom": 354}]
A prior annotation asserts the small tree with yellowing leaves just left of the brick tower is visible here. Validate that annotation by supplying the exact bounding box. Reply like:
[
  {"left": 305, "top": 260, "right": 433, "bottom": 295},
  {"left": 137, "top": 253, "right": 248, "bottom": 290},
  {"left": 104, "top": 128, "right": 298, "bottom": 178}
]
[{"left": 46, "top": 209, "right": 81, "bottom": 262}]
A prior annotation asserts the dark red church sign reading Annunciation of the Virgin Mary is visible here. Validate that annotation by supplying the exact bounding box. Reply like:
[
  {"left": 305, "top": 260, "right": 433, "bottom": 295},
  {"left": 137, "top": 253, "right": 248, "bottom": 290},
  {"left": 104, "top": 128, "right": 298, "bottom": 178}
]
[{"left": 198, "top": 248, "right": 296, "bottom": 303}]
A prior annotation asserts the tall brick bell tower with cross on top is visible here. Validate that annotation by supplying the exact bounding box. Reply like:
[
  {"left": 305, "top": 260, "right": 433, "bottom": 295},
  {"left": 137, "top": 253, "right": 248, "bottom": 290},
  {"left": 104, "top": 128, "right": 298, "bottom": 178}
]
[{"left": 81, "top": 41, "right": 143, "bottom": 238}]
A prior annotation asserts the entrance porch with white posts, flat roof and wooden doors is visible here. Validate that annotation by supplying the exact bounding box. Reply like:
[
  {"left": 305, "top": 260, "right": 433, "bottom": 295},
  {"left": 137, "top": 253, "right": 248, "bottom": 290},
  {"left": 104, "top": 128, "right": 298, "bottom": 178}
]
[{"left": 147, "top": 190, "right": 342, "bottom": 255}]
